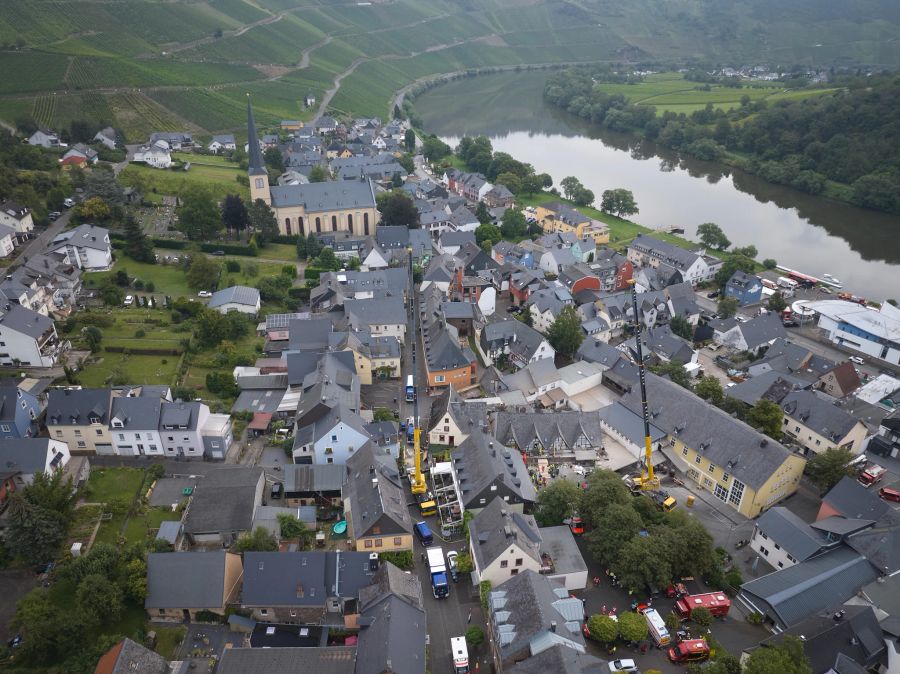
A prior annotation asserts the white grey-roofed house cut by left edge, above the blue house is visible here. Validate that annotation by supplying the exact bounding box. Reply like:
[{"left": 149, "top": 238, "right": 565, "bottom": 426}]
[{"left": 0, "top": 304, "right": 68, "bottom": 367}]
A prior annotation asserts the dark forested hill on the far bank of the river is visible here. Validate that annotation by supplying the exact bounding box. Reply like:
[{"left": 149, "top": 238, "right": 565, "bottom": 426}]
[{"left": 544, "top": 69, "right": 900, "bottom": 213}]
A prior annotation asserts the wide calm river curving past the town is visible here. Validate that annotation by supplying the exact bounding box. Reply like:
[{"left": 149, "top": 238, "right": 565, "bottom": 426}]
[{"left": 415, "top": 72, "right": 900, "bottom": 300}]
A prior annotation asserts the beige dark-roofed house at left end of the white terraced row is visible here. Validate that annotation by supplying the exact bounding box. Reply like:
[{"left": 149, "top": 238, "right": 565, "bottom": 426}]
[{"left": 47, "top": 388, "right": 115, "bottom": 456}]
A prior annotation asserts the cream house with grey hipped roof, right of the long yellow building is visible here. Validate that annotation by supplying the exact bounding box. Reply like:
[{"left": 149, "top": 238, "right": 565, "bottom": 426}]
[{"left": 781, "top": 391, "right": 868, "bottom": 456}]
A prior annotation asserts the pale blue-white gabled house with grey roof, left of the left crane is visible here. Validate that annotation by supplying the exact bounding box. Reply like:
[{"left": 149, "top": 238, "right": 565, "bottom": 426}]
[{"left": 292, "top": 404, "right": 369, "bottom": 464}]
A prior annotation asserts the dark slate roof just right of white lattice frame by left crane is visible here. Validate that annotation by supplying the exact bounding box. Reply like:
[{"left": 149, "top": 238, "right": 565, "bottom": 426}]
[{"left": 451, "top": 429, "right": 537, "bottom": 504}]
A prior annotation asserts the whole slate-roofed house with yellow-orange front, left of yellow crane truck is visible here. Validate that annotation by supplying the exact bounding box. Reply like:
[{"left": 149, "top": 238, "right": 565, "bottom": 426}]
[{"left": 344, "top": 443, "right": 413, "bottom": 552}]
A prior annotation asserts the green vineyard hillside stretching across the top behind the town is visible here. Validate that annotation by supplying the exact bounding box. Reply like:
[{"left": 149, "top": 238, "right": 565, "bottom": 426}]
[{"left": 0, "top": 0, "right": 900, "bottom": 141}]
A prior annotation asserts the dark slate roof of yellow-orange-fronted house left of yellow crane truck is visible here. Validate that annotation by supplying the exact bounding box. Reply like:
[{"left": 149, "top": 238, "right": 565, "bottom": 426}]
[{"left": 343, "top": 442, "right": 412, "bottom": 538}]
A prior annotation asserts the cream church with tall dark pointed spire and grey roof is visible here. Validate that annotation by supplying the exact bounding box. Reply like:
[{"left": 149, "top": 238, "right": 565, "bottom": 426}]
[{"left": 247, "top": 98, "right": 381, "bottom": 236}]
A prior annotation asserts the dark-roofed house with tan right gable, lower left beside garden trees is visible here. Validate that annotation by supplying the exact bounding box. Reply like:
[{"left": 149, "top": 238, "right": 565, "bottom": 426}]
[{"left": 144, "top": 550, "right": 244, "bottom": 623}]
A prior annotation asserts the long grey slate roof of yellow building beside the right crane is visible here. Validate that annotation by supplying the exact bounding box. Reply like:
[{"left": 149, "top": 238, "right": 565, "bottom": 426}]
[{"left": 620, "top": 373, "right": 791, "bottom": 489}]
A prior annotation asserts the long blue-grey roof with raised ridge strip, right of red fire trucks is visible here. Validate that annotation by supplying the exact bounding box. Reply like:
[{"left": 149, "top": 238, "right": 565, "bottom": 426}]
[{"left": 741, "top": 547, "right": 878, "bottom": 626}]
